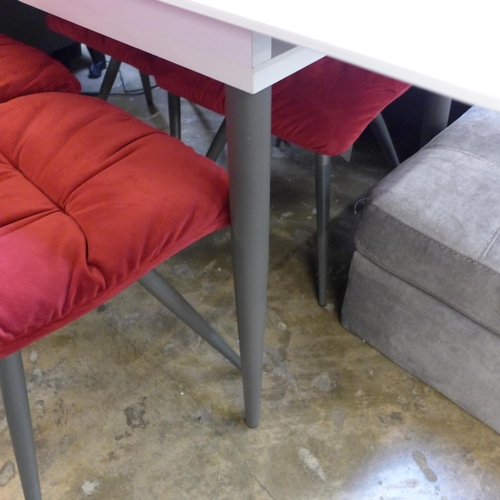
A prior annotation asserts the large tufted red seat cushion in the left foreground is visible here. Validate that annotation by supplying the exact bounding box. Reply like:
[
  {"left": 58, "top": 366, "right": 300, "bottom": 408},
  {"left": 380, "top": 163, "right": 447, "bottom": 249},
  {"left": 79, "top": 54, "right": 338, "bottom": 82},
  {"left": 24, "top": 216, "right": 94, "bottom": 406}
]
[{"left": 0, "top": 93, "right": 229, "bottom": 357}]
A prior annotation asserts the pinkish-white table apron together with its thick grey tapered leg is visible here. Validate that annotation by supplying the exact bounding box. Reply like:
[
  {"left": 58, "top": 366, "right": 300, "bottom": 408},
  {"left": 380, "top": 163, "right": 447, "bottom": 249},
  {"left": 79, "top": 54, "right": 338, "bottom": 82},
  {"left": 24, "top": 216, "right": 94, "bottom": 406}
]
[{"left": 26, "top": 0, "right": 322, "bottom": 427}]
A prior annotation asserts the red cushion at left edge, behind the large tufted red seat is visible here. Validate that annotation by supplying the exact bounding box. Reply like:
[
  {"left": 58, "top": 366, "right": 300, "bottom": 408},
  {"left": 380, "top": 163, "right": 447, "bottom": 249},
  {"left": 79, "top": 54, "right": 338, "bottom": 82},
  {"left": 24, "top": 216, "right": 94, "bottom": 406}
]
[{"left": 0, "top": 34, "right": 81, "bottom": 102}]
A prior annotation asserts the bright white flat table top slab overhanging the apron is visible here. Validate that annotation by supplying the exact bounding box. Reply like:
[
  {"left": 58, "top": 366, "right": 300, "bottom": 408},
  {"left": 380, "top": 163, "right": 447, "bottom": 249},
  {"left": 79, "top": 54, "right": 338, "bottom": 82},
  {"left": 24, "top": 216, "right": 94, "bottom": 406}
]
[{"left": 158, "top": 0, "right": 500, "bottom": 110}]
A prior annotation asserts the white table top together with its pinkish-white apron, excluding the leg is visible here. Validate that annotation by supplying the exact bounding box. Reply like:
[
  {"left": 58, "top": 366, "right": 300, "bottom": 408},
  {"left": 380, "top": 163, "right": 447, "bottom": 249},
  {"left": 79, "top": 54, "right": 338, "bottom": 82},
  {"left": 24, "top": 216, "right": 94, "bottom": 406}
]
[{"left": 23, "top": 0, "right": 500, "bottom": 110}]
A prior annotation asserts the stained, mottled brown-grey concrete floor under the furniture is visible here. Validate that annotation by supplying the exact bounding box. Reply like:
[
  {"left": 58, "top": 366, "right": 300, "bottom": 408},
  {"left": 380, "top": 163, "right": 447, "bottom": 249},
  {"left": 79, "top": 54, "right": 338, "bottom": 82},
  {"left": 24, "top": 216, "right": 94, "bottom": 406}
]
[{"left": 0, "top": 51, "right": 500, "bottom": 500}]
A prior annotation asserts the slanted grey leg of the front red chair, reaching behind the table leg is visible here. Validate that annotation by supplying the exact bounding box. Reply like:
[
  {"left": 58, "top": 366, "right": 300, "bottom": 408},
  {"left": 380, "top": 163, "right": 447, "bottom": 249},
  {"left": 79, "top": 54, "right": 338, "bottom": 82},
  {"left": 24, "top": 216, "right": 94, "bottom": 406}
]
[{"left": 139, "top": 270, "right": 241, "bottom": 370}]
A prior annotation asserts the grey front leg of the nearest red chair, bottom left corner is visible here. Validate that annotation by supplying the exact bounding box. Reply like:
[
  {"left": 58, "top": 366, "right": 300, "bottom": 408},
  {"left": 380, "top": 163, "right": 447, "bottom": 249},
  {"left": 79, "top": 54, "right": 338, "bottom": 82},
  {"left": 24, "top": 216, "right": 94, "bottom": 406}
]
[{"left": 0, "top": 352, "right": 42, "bottom": 500}]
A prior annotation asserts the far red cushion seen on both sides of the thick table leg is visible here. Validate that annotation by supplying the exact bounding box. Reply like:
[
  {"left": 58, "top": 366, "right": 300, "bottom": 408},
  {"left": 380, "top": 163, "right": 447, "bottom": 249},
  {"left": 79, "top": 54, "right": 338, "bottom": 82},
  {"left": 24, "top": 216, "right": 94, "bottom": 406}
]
[{"left": 153, "top": 57, "right": 410, "bottom": 156}]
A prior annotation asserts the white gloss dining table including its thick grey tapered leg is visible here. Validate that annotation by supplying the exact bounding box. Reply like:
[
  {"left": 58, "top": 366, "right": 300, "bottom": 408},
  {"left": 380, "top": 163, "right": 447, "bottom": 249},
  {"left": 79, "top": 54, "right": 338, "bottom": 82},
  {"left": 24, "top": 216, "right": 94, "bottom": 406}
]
[{"left": 23, "top": 0, "right": 500, "bottom": 427}]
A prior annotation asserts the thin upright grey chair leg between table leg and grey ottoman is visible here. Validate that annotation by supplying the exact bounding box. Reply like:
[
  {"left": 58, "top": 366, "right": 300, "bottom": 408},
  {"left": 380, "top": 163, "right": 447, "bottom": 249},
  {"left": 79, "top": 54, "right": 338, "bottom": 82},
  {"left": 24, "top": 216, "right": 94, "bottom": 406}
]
[{"left": 316, "top": 154, "right": 331, "bottom": 306}]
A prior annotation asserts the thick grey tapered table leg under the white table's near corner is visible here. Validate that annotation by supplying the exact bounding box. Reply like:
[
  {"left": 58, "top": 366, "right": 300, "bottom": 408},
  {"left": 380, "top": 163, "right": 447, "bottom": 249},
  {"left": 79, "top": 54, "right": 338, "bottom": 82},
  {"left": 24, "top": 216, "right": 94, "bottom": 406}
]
[{"left": 226, "top": 86, "right": 271, "bottom": 427}]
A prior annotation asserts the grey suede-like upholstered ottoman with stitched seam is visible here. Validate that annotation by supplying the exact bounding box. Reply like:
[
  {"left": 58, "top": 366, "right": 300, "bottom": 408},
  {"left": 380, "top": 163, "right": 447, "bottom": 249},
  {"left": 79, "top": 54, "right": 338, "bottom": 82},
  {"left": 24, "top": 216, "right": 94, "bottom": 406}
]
[{"left": 342, "top": 108, "right": 500, "bottom": 432}]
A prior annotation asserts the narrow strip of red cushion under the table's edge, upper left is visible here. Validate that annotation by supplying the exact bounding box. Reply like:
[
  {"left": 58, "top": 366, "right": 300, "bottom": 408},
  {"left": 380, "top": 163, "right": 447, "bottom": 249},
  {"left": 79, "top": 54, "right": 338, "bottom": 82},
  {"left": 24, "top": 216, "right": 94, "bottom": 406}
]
[{"left": 45, "top": 14, "right": 157, "bottom": 75}]
